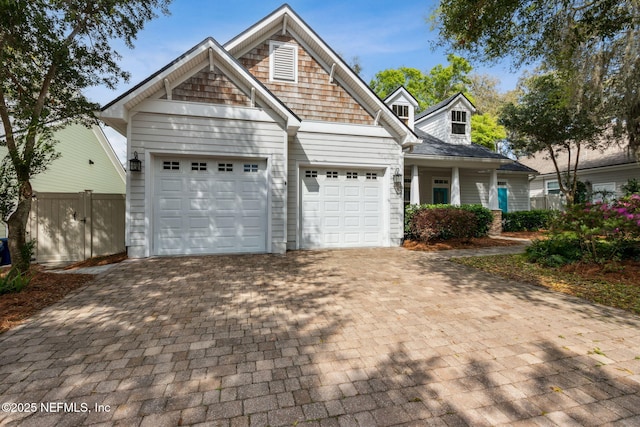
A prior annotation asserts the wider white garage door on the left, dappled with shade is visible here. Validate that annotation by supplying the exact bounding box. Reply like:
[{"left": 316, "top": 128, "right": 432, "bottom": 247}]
[{"left": 153, "top": 158, "right": 267, "bottom": 255}]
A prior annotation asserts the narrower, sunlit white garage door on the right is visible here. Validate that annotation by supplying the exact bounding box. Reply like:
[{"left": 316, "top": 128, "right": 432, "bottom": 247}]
[{"left": 300, "top": 168, "right": 384, "bottom": 249}]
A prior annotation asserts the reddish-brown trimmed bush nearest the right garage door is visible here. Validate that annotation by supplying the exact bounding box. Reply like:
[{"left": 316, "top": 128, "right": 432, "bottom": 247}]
[{"left": 409, "top": 206, "right": 478, "bottom": 242}]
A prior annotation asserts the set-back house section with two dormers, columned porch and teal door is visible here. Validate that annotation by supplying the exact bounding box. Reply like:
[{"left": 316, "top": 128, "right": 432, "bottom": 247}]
[{"left": 385, "top": 88, "right": 536, "bottom": 212}]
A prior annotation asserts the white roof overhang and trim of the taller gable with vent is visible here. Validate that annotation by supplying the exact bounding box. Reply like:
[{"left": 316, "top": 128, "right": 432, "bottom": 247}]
[{"left": 224, "top": 4, "right": 420, "bottom": 146}]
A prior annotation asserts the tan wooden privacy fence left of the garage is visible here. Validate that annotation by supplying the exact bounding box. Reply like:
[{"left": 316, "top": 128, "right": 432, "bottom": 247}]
[{"left": 28, "top": 191, "right": 125, "bottom": 262}]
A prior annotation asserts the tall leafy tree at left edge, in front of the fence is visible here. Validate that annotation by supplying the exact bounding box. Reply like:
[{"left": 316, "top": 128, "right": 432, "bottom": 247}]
[{"left": 0, "top": 0, "right": 170, "bottom": 274}]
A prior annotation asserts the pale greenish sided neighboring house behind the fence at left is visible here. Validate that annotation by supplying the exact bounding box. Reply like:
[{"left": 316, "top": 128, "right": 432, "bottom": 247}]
[{"left": 0, "top": 124, "right": 125, "bottom": 236}]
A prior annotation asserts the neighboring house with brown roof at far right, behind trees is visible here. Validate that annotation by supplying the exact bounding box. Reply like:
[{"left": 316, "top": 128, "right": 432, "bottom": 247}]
[{"left": 520, "top": 144, "right": 640, "bottom": 202}]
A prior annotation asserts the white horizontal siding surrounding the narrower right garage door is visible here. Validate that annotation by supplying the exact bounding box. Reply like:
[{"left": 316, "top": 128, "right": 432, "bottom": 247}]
[{"left": 287, "top": 132, "right": 404, "bottom": 249}]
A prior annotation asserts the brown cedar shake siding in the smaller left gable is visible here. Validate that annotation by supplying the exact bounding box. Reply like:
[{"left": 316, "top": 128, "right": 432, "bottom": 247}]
[{"left": 169, "top": 68, "right": 251, "bottom": 107}]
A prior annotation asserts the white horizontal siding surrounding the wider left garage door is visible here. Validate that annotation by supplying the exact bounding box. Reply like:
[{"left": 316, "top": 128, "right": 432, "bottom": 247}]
[{"left": 127, "top": 112, "right": 286, "bottom": 257}]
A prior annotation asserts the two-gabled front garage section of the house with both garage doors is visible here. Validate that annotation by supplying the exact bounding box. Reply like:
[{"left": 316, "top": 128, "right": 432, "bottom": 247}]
[{"left": 101, "top": 5, "right": 528, "bottom": 258}]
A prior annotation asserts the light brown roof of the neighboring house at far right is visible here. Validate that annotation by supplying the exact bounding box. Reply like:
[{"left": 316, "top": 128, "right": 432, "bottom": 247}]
[{"left": 519, "top": 144, "right": 640, "bottom": 175}]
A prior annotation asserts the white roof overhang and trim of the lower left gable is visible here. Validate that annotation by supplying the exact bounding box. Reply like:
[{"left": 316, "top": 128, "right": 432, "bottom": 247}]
[{"left": 98, "top": 37, "right": 300, "bottom": 135}]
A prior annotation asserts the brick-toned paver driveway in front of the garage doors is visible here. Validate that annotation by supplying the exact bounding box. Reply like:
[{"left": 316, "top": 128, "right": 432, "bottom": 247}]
[{"left": 0, "top": 248, "right": 640, "bottom": 427}]
